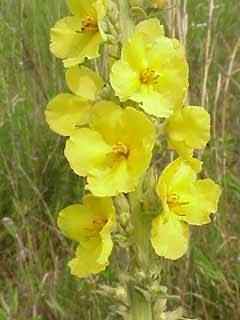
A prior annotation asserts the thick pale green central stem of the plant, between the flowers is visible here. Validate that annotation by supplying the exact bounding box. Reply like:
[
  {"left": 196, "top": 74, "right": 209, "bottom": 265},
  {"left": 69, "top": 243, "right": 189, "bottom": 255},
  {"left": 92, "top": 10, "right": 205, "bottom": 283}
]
[{"left": 118, "top": 0, "right": 153, "bottom": 320}]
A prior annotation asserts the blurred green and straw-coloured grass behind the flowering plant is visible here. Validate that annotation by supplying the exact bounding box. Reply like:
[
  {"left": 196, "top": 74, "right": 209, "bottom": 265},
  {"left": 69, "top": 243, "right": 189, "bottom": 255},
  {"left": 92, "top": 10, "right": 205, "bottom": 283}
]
[{"left": 0, "top": 0, "right": 240, "bottom": 320}]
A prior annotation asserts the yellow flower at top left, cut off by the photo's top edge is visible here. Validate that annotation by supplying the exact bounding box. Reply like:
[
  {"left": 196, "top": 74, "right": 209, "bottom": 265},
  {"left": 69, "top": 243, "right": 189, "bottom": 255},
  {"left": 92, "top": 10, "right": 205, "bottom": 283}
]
[{"left": 50, "top": 0, "right": 106, "bottom": 67}]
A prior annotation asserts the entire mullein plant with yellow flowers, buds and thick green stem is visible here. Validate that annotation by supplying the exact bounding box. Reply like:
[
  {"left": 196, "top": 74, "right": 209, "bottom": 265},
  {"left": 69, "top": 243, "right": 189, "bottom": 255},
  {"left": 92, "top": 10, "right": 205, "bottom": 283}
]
[{"left": 45, "top": 0, "right": 221, "bottom": 320}]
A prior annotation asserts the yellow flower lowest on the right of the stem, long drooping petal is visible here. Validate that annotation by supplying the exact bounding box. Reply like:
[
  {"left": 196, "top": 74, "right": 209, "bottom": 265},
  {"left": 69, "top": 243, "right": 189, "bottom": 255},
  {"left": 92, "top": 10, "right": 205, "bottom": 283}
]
[{"left": 151, "top": 158, "right": 221, "bottom": 260}]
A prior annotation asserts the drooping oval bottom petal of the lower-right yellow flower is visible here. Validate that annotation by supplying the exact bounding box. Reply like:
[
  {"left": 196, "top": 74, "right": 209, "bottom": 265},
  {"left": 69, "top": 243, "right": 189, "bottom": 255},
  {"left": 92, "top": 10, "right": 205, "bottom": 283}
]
[{"left": 151, "top": 213, "right": 189, "bottom": 260}]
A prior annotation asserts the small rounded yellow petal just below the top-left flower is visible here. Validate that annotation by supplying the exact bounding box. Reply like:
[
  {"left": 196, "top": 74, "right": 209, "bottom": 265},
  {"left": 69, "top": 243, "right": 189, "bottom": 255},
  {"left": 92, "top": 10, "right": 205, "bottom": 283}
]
[{"left": 66, "top": 66, "right": 103, "bottom": 101}]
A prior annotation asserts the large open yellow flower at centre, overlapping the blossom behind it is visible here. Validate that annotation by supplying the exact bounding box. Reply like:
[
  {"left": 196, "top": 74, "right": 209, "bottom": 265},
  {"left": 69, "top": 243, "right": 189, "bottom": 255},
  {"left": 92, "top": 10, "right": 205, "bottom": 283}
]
[{"left": 65, "top": 101, "right": 155, "bottom": 197}]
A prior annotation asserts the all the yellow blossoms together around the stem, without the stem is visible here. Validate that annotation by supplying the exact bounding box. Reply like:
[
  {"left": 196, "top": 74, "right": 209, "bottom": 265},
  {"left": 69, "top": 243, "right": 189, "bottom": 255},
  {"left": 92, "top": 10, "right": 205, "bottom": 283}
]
[{"left": 46, "top": 0, "right": 221, "bottom": 277}]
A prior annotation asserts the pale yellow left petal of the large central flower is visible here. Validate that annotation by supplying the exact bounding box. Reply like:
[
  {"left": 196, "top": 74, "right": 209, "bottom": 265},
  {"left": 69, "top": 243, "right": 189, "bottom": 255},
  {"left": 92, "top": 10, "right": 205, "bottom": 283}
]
[{"left": 65, "top": 128, "right": 112, "bottom": 176}]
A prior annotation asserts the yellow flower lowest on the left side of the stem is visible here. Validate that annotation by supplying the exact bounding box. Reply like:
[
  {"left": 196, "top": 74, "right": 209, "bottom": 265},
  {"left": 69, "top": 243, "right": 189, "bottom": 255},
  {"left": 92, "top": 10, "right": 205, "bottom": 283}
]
[{"left": 58, "top": 195, "right": 115, "bottom": 278}]
